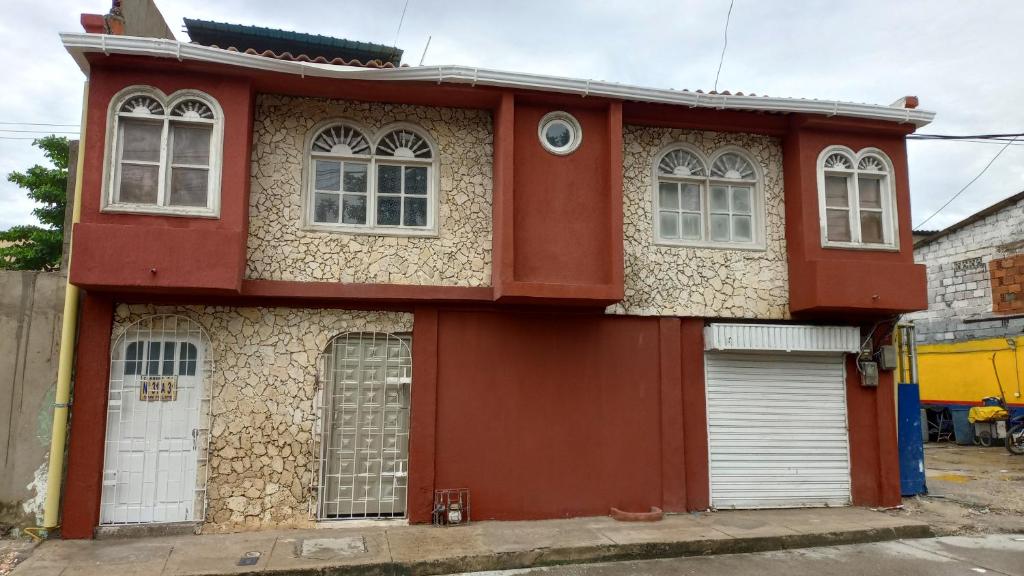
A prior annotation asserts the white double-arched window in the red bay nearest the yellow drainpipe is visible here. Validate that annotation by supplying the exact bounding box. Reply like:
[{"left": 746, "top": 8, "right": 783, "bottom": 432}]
[{"left": 104, "top": 87, "right": 223, "bottom": 216}]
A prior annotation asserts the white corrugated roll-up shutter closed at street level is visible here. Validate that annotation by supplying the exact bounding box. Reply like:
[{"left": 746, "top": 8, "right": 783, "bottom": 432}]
[{"left": 707, "top": 353, "right": 850, "bottom": 508}]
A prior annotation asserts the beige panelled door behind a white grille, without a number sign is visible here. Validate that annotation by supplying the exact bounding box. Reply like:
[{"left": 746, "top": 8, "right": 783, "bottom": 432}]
[{"left": 317, "top": 332, "right": 413, "bottom": 520}]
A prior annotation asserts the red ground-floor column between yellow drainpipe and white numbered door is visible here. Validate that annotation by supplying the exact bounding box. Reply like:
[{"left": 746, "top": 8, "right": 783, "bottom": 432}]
[{"left": 60, "top": 292, "right": 114, "bottom": 538}]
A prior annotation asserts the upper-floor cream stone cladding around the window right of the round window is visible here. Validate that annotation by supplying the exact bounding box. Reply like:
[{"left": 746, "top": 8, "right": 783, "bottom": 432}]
[{"left": 608, "top": 126, "right": 790, "bottom": 319}]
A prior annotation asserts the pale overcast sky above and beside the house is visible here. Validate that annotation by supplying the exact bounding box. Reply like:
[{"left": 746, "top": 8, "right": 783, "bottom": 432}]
[{"left": 0, "top": 0, "right": 1024, "bottom": 230}]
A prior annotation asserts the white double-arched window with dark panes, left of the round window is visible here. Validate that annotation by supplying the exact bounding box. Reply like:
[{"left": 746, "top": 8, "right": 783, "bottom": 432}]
[{"left": 307, "top": 121, "right": 437, "bottom": 234}]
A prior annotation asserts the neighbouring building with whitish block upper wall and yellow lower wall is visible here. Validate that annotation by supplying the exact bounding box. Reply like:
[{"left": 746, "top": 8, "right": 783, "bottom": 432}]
[{"left": 904, "top": 192, "right": 1024, "bottom": 408}]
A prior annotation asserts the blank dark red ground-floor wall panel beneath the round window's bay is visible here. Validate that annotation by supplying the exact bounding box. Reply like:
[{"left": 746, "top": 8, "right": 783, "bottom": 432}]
[{"left": 434, "top": 312, "right": 663, "bottom": 520}]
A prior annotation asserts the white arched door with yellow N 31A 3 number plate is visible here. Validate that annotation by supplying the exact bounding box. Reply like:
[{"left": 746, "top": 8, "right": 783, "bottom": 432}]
[{"left": 100, "top": 316, "right": 209, "bottom": 524}]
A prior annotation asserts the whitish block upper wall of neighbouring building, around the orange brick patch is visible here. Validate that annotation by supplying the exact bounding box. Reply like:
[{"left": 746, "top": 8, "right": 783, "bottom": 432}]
[{"left": 904, "top": 192, "right": 1024, "bottom": 344}]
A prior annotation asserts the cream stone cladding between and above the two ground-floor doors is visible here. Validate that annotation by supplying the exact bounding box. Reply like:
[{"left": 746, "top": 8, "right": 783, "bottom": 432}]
[{"left": 112, "top": 304, "right": 413, "bottom": 531}]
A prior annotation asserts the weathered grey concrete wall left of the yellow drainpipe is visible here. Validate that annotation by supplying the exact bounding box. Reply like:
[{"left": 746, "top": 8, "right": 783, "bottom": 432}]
[{"left": 0, "top": 271, "right": 66, "bottom": 527}]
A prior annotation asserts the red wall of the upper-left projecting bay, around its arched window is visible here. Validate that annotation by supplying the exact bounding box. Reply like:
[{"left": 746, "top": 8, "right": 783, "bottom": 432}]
[{"left": 71, "top": 66, "right": 253, "bottom": 292}]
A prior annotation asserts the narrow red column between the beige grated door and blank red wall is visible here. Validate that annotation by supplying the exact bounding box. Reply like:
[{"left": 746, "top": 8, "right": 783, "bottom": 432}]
[{"left": 408, "top": 307, "right": 438, "bottom": 524}]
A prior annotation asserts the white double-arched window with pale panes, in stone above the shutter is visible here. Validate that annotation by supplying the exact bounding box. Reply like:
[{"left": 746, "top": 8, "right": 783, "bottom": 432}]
[{"left": 654, "top": 145, "right": 764, "bottom": 248}]
